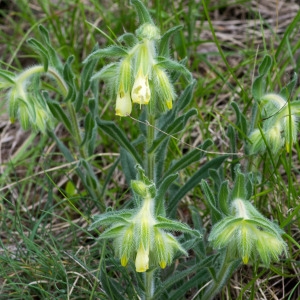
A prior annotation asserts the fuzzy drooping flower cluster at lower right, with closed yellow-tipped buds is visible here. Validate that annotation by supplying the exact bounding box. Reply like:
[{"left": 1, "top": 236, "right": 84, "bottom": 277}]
[{"left": 209, "top": 199, "right": 286, "bottom": 266}]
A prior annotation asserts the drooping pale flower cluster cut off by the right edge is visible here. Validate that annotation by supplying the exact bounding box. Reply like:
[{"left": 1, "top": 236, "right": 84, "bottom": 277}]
[{"left": 249, "top": 93, "right": 300, "bottom": 154}]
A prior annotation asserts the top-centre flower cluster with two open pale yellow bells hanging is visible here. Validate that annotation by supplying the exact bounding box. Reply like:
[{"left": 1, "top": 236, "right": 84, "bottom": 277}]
[{"left": 85, "top": 20, "right": 190, "bottom": 117}]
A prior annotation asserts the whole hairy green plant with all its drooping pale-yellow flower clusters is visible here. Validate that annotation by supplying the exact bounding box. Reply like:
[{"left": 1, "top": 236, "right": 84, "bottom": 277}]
[{"left": 0, "top": 0, "right": 292, "bottom": 300}]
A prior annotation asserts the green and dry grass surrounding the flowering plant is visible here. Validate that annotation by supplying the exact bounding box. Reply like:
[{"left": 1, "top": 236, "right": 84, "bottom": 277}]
[{"left": 0, "top": 0, "right": 300, "bottom": 299}]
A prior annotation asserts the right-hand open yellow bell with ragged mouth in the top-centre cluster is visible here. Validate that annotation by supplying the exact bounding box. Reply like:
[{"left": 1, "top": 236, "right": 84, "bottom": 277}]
[{"left": 131, "top": 71, "right": 151, "bottom": 104}]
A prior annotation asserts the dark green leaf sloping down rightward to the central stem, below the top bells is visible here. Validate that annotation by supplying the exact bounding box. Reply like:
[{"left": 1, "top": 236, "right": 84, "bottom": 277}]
[{"left": 96, "top": 118, "right": 143, "bottom": 166}]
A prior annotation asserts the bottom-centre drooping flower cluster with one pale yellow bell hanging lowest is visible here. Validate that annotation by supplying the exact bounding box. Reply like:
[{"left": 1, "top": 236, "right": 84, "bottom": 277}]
[{"left": 90, "top": 169, "right": 200, "bottom": 272}]
